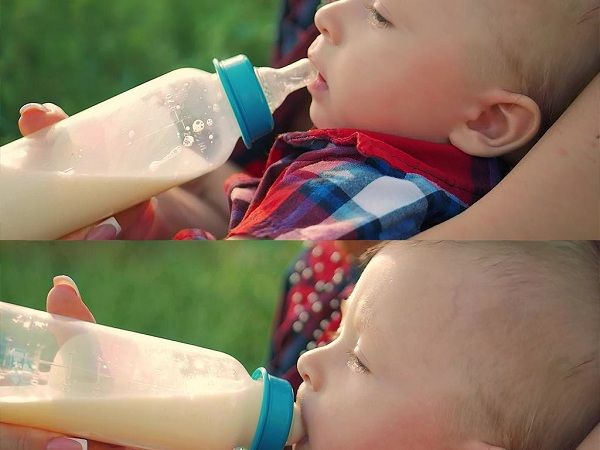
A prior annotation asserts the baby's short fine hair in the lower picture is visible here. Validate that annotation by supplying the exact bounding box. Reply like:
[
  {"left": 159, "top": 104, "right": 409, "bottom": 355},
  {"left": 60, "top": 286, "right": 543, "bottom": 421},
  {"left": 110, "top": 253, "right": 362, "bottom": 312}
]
[{"left": 362, "top": 241, "right": 600, "bottom": 450}]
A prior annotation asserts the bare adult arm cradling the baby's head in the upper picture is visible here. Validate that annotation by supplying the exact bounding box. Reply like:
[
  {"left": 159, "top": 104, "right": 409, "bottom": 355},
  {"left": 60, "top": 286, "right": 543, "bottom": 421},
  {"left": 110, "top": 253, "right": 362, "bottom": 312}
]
[{"left": 416, "top": 74, "right": 600, "bottom": 240}]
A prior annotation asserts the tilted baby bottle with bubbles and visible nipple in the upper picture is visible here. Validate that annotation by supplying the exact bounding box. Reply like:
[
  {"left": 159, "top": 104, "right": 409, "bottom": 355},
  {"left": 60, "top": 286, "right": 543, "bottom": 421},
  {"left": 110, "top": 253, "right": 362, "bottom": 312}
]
[{"left": 0, "top": 55, "right": 316, "bottom": 240}]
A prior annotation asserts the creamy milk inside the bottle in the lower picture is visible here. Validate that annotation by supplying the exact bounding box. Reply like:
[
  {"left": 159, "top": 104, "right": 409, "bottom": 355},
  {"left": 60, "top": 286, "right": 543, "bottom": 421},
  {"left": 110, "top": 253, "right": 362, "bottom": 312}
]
[{"left": 0, "top": 382, "right": 262, "bottom": 450}]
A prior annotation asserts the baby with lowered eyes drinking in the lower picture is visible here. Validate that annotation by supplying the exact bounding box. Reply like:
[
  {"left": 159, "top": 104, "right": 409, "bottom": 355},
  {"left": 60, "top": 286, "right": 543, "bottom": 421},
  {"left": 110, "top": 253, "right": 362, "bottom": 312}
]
[{"left": 296, "top": 241, "right": 600, "bottom": 450}]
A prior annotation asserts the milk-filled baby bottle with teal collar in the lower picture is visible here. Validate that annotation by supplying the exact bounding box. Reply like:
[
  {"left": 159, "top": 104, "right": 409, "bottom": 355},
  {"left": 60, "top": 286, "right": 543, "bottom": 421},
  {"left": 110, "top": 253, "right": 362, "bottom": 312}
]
[{"left": 0, "top": 302, "right": 304, "bottom": 450}]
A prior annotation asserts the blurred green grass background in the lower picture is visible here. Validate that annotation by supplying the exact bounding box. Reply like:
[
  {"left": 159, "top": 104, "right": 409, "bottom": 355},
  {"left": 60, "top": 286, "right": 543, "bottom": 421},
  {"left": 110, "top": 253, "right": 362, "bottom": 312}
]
[{"left": 0, "top": 241, "right": 302, "bottom": 371}]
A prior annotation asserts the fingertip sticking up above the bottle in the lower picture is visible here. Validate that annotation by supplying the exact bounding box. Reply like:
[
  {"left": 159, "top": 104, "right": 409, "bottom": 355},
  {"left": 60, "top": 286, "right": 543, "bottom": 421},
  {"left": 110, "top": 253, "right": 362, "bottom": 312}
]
[{"left": 46, "top": 275, "right": 96, "bottom": 323}]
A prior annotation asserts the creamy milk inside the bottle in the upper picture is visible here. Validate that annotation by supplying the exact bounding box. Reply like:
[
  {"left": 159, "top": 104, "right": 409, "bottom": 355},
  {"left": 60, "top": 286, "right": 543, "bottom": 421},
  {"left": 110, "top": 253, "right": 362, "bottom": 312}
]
[{"left": 0, "top": 168, "right": 209, "bottom": 240}]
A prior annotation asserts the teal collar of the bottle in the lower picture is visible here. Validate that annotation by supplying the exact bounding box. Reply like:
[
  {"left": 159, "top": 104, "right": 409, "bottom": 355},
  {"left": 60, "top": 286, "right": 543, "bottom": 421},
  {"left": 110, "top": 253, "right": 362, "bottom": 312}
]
[{"left": 250, "top": 367, "right": 294, "bottom": 450}]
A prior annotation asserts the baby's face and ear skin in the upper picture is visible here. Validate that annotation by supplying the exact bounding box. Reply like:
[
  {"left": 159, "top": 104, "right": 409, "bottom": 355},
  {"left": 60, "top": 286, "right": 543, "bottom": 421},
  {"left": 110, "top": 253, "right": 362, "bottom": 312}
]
[{"left": 308, "top": 0, "right": 540, "bottom": 157}]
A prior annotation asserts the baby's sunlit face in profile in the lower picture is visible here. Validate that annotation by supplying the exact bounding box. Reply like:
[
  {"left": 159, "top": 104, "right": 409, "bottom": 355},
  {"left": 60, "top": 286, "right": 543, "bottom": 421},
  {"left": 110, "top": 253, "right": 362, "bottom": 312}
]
[{"left": 296, "top": 245, "right": 493, "bottom": 450}]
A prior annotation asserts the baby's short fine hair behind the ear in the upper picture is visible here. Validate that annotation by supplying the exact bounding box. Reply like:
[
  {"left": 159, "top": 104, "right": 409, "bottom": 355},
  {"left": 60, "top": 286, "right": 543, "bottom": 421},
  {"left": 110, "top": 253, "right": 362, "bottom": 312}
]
[{"left": 476, "top": 0, "right": 600, "bottom": 134}]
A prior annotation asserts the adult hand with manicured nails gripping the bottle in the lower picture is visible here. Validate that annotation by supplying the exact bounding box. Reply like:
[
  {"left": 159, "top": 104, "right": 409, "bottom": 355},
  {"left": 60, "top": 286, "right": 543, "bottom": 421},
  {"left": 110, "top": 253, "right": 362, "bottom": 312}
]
[{"left": 0, "top": 275, "right": 127, "bottom": 450}]
